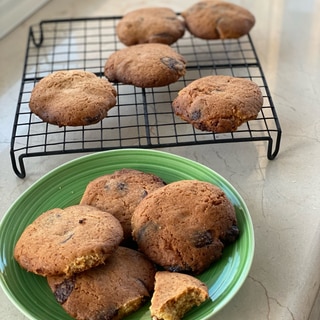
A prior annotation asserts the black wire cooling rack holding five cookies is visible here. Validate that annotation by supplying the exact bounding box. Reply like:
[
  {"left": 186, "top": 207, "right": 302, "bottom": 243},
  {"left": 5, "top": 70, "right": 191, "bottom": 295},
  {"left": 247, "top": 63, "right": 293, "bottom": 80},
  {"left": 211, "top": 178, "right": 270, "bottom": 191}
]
[{"left": 10, "top": 17, "right": 281, "bottom": 178}]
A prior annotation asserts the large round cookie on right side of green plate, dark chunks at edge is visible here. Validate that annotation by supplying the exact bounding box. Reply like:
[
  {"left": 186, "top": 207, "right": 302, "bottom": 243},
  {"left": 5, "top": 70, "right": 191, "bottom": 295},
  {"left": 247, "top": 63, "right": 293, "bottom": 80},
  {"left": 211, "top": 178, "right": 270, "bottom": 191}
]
[{"left": 132, "top": 180, "right": 239, "bottom": 274}]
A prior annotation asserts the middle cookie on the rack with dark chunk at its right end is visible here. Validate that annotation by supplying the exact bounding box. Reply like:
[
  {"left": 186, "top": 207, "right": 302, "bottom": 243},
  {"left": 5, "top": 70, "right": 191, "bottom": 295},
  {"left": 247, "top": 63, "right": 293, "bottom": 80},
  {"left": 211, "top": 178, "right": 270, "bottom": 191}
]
[{"left": 104, "top": 43, "right": 186, "bottom": 88}]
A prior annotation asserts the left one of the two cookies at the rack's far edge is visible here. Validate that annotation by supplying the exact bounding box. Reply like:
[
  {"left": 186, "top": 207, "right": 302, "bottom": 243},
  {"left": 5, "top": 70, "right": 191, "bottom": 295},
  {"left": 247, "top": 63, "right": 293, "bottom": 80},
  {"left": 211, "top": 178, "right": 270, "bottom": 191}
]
[{"left": 116, "top": 7, "right": 185, "bottom": 46}]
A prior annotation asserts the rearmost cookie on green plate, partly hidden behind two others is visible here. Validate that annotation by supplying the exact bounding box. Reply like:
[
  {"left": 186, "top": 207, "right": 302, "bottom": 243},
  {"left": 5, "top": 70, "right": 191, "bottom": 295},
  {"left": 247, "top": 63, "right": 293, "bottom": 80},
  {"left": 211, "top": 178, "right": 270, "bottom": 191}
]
[{"left": 80, "top": 169, "right": 165, "bottom": 240}]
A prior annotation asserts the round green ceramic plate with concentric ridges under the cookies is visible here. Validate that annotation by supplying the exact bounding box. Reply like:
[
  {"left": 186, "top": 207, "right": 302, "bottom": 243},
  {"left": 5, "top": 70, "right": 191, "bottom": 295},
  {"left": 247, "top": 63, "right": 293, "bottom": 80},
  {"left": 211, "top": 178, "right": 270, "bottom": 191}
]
[{"left": 0, "top": 149, "right": 254, "bottom": 320}]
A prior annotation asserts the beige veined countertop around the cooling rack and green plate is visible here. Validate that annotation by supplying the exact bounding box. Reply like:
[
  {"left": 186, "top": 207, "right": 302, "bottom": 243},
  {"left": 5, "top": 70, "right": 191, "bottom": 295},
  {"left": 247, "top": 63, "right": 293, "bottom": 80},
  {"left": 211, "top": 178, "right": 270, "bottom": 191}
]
[{"left": 0, "top": 0, "right": 320, "bottom": 320}]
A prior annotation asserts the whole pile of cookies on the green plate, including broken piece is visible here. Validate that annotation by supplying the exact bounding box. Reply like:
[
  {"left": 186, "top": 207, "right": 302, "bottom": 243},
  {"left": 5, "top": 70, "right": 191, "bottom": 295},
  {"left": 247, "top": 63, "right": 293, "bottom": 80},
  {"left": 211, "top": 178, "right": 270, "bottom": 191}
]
[{"left": 14, "top": 169, "right": 239, "bottom": 320}]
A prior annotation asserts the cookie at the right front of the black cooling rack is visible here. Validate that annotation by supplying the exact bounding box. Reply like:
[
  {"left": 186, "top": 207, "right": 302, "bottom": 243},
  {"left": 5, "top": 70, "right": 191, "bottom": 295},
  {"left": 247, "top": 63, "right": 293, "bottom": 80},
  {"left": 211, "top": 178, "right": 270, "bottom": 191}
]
[{"left": 172, "top": 76, "right": 263, "bottom": 133}]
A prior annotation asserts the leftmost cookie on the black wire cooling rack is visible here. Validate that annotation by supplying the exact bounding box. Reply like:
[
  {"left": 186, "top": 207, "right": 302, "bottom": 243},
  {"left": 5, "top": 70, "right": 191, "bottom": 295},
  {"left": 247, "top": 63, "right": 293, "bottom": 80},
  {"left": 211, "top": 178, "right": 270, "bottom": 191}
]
[{"left": 29, "top": 70, "right": 117, "bottom": 127}]
